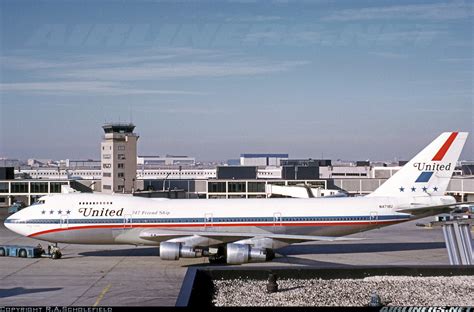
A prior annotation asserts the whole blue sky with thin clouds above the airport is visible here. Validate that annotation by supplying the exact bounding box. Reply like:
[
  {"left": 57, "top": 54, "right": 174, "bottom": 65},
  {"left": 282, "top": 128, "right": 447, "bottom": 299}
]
[{"left": 0, "top": 0, "right": 474, "bottom": 160}]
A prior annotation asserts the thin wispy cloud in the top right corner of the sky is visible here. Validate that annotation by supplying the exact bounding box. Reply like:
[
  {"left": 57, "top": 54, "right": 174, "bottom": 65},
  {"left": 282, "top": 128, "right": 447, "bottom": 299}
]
[{"left": 322, "top": 2, "right": 473, "bottom": 22}]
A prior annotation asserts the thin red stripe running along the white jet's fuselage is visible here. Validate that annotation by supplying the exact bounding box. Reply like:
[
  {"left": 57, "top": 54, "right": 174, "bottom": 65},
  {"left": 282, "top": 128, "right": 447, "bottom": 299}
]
[{"left": 28, "top": 220, "right": 407, "bottom": 237}]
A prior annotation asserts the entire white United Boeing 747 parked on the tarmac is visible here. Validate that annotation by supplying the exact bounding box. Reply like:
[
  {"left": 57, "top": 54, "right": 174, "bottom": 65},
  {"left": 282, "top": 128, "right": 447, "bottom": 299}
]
[{"left": 5, "top": 132, "right": 468, "bottom": 264}]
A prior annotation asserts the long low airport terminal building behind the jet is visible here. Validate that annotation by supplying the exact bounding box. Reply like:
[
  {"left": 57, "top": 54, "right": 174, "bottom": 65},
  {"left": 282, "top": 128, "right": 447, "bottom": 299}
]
[{"left": 0, "top": 161, "right": 474, "bottom": 207}]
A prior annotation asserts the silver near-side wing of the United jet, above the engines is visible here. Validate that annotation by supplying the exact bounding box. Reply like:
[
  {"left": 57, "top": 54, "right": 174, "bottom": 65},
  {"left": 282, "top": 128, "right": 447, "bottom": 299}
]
[{"left": 140, "top": 228, "right": 360, "bottom": 246}]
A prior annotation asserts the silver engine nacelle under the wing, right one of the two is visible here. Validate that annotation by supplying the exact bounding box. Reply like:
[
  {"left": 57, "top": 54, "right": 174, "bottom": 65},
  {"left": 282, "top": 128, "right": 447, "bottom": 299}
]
[{"left": 226, "top": 244, "right": 274, "bottom": 264}]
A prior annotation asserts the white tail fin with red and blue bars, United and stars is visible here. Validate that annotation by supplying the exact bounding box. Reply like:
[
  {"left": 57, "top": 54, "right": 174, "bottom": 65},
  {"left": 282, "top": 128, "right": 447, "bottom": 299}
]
[{"left": 367, "top": 132, "right": 468, "bottom": 197}]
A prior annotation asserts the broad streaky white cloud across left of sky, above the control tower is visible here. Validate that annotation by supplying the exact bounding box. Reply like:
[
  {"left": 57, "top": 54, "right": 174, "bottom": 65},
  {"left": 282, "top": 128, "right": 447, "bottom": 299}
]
[{"left": 0, "top": 48, "right": 308, "bottom": 95}]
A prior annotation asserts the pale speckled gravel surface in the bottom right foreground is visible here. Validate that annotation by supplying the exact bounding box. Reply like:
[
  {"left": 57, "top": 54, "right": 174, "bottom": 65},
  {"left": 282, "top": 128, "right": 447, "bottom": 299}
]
[{"left": 213, "top": 276, "right": 474, "bottom": 306}]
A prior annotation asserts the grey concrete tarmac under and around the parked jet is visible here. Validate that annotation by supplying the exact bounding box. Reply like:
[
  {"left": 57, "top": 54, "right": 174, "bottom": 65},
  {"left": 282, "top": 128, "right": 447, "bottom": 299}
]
[{"left": 0, "top": 217, "right": 456, "bottom": 306}]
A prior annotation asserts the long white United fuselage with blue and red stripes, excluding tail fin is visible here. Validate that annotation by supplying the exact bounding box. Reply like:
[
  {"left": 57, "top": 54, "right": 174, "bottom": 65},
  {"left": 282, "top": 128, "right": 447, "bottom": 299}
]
[{"left": 5, "top": 194, "right": 454, "bottom": 245}]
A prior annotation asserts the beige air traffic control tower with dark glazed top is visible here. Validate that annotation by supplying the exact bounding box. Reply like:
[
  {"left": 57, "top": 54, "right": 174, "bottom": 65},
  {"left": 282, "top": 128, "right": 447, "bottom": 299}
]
[{"left": 101, "top": 123, "right": 139, "bottom": 193}]
